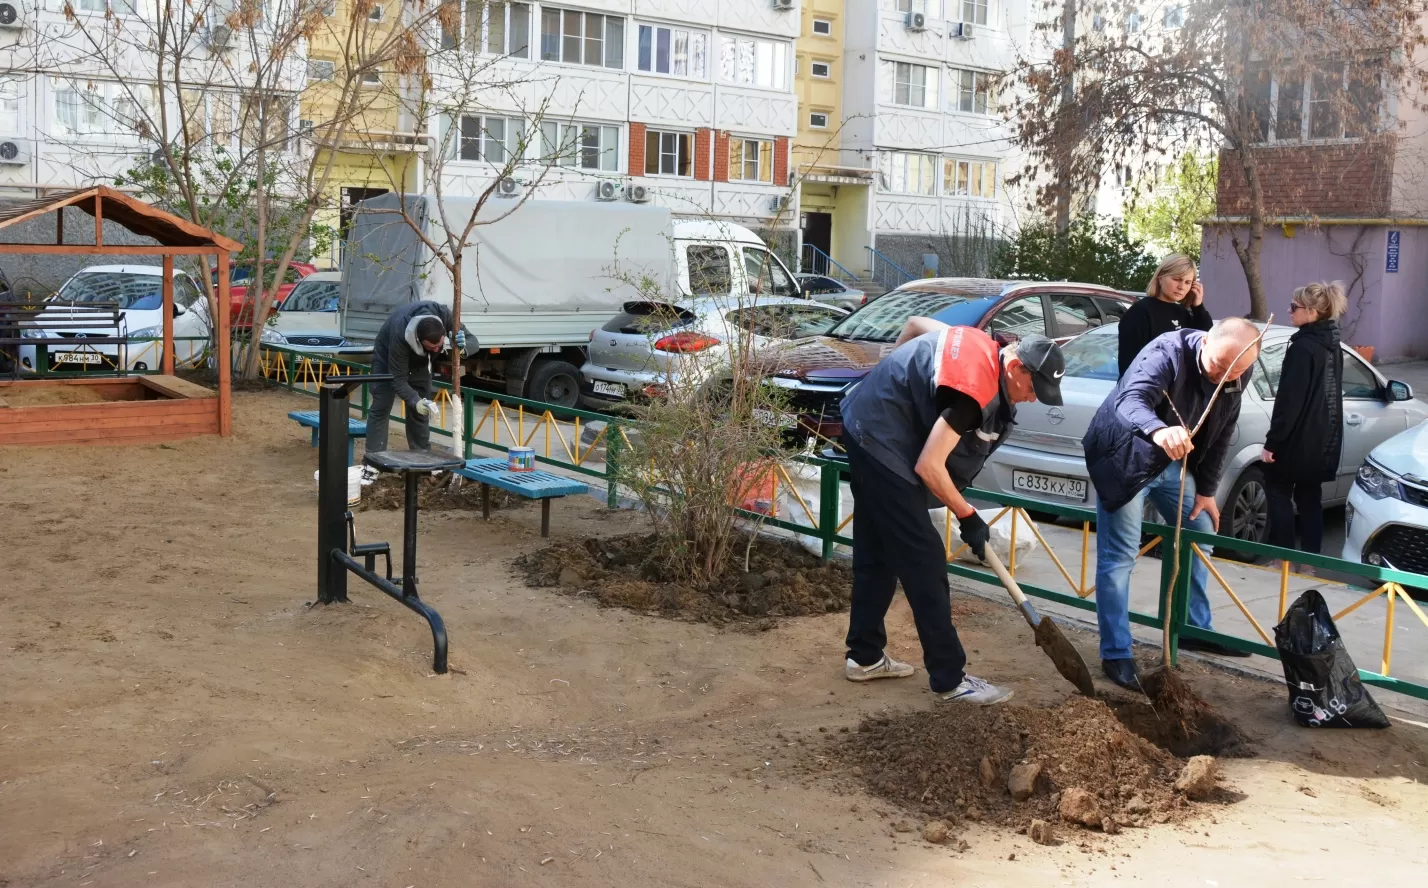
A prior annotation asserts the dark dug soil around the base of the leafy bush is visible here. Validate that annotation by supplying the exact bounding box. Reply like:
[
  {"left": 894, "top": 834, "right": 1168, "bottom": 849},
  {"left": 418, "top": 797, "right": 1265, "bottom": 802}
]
[{"left": 516, "top": 534, "right": 853, "bottom": 625}]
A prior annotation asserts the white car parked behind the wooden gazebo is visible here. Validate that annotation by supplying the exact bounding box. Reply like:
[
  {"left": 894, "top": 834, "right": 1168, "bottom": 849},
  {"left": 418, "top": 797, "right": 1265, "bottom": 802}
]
[{"left": 20, "top": 266, "right": 208, "bottom": 373}]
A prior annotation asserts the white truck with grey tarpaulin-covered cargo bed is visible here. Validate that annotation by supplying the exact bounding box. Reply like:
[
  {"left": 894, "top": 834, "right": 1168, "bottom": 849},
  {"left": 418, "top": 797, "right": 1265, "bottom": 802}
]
[{"left": 340, "top": 194, "right": 800, "bottom": 407}]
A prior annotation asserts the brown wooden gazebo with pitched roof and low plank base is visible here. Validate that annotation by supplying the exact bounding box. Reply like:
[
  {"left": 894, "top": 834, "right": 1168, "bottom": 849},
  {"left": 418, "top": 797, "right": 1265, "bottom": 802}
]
[{"left": 0, "top": 186, "right": 243, "bottom": 445}]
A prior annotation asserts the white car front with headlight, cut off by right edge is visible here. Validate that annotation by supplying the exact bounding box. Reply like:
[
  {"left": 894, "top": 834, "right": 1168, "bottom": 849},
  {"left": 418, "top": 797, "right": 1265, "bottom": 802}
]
[{"left": 1344, "top": 425, "right": 1428, "bottom": 574}]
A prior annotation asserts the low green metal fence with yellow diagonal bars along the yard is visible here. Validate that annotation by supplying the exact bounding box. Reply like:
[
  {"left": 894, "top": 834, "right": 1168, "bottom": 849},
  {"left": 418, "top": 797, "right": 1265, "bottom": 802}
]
[{"left": 261, "top": 347, "right": 1428, "bottom": 700}]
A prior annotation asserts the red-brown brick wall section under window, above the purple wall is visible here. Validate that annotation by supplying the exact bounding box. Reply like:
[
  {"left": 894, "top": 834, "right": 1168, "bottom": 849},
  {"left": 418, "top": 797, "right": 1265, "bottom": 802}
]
[{"left": 1215, "top": 140, "right": 1394, "bottom": 217}]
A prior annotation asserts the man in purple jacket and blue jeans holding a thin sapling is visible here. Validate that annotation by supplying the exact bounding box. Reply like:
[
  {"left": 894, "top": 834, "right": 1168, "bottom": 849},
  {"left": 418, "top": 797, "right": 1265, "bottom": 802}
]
[{"left": 1081, "top": 318, "right": 1259, "bottom": 691}]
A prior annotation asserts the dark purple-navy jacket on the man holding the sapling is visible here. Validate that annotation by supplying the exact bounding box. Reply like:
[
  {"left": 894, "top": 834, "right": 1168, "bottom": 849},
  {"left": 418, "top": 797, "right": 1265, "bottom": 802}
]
[{"left": 1081, "top": 330, "right": 1252, "bottom": 511}]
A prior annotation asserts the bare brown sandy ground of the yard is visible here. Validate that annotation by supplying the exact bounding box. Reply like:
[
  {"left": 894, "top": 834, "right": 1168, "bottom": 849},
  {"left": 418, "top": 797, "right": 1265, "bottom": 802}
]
[{"left": 0, "top": 393, "right": 1428, "bottom": 888}]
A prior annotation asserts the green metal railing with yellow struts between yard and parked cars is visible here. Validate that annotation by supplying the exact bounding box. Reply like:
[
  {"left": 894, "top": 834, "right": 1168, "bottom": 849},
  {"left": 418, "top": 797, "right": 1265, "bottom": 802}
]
[{"left": 261, "top": 347, "right": 1428, "bottom": 700}]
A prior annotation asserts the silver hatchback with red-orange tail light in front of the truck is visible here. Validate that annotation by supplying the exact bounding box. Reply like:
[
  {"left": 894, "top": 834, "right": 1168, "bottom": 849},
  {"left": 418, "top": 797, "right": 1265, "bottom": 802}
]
[{"left": 580, "top": 296, "right": 848, "bottom": 407}]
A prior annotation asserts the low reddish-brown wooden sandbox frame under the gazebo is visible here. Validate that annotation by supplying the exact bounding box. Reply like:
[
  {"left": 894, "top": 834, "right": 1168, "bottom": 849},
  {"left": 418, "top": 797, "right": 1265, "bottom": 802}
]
[{"left": 0, "top": 375, "right": 220, "bottom": 445}]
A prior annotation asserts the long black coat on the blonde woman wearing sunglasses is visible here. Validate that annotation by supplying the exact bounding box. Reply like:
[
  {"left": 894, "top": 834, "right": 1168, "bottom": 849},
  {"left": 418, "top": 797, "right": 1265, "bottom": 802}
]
[{"left": 1264, "top": 320, "right": 1344, "bottom": 481}]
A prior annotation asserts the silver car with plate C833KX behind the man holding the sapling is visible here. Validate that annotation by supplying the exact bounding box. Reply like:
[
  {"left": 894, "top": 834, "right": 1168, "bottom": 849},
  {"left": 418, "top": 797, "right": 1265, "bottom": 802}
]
[{"left": 974, "top": 324, "right": 1428, "bottom": 543}]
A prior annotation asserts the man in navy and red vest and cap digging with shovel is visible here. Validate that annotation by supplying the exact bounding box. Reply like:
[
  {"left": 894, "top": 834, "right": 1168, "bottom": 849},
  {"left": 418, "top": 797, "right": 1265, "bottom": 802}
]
[{"left": 843, "top": 318, "right": 1065, "bottom": 705}]
